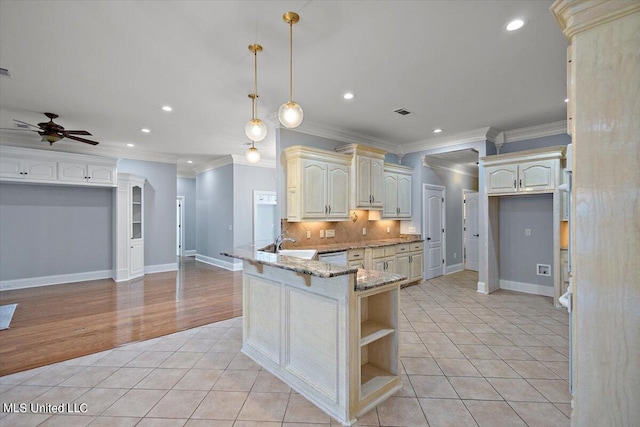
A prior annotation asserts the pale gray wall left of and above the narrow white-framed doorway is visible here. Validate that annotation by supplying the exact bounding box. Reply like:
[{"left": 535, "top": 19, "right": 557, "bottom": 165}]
[{"left": 233, "top": 164, "right": 279, "bottom": 246}]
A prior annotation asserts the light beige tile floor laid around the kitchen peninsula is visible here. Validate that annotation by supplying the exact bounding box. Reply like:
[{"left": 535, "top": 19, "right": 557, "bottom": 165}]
[{"left": 0, "top": 271, "right": 570, "bottom": 427}]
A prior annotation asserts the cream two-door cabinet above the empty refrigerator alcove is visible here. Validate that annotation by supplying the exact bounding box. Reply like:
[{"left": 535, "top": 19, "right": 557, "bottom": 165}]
[{"left": 482, "top": 147, "right": 565, "bottom": 195}]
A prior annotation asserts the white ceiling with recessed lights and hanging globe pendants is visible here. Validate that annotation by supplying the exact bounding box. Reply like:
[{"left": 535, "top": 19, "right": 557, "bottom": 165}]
[{"left": 0, "top": 0, "right": 567, "bottom": 174}]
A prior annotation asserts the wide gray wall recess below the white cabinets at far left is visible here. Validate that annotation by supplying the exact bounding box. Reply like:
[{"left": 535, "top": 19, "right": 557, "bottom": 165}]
[{"left": 0, "top": 183, "right": 114, "bottom": 281}]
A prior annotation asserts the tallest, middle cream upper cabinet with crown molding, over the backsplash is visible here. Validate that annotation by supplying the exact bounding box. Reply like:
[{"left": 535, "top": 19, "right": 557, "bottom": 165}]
[{"left": 336, "top": 144, "right": 386, "bottom": 210}]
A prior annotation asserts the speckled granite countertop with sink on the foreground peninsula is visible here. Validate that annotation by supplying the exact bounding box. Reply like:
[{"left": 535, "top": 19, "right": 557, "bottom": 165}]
[{"left": 221, "top": 245, "right": 406, "bottom": 291}]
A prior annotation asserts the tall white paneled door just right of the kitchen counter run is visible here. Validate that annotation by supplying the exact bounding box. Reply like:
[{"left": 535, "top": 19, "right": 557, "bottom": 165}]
[{"left": 423, "top": 186, "right": 444, "bottom": 279}]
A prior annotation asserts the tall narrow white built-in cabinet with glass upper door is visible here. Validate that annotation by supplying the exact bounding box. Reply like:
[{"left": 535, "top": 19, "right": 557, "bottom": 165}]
[{"left": 114, "top": 173, "right": 145, "bottom": 282}]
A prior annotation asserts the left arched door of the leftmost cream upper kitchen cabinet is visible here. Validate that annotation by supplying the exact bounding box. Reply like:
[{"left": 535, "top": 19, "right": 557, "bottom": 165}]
[{"left": 301, "top": 160, "right": 329, "bottom": 218}]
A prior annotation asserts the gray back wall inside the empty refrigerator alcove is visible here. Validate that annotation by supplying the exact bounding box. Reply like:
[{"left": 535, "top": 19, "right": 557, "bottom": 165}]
[{"left": 499, "top": 194, "right": 556, "bottom": 286}]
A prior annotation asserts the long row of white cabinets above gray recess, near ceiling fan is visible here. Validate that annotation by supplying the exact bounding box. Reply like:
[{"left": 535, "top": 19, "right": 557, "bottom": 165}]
[{"left": 0, "top": 147, "right": 117, "bottom": 187}]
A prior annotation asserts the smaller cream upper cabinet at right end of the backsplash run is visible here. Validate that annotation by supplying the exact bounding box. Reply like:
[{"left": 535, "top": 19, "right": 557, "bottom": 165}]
[{"left": 382, "top": 163, "right": 413, "bottom": 218}]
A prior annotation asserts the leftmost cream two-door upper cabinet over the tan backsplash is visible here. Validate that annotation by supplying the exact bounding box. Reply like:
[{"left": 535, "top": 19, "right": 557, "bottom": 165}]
[{"left": 285, "top": 145, "right": 351, "bottom": 222}]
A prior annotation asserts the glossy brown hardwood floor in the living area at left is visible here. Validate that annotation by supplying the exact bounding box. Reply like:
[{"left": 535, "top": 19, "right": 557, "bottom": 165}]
[{"left": 0, "top": 258, "right": 242, "bottom": 376}]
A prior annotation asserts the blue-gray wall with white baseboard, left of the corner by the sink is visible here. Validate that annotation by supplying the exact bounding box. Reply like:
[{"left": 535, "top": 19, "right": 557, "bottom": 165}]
[{"left": 196, "top": 165, "right": 234, "bottom": 262}]
